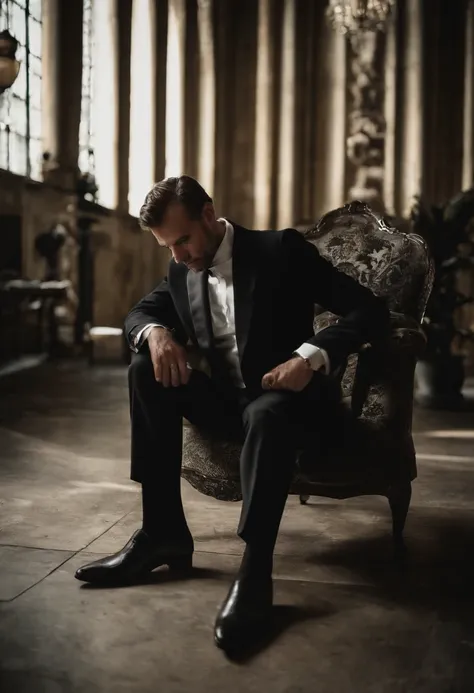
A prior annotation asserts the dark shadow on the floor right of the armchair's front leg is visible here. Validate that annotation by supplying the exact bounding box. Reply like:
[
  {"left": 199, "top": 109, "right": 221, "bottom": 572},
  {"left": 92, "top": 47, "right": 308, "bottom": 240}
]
[{"left": 309, "top": 508, "right": 474, "bottom": 623}]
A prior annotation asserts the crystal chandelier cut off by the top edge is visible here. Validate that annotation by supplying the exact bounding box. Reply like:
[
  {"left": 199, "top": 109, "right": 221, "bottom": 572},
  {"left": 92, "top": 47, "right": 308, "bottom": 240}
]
[{"left": 326, "top": 0, "right": 395, "bottom": 35}]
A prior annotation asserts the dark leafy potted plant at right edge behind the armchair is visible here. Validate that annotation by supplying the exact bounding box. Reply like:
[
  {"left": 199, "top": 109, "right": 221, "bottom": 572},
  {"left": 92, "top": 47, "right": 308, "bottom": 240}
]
[{"left": 410, "top": 188, "right": 474, "bottom": 409}]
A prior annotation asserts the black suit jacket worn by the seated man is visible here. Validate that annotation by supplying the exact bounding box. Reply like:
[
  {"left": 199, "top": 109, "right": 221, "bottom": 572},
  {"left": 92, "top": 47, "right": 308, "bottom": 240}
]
[{"left": 125, "top": 224, "right": 389, "bottom": 387}]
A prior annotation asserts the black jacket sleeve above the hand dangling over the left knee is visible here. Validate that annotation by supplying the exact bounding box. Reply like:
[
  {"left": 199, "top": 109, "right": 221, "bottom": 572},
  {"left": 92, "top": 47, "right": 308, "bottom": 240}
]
[{"left": 125, "top": 277, "right": 187, "bottom": 351}]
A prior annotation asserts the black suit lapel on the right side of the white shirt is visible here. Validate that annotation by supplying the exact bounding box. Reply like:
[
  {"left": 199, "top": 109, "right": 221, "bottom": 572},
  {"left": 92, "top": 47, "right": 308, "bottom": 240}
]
[{"left": 232, "top": 225, "right": 257, "bottom": 362}]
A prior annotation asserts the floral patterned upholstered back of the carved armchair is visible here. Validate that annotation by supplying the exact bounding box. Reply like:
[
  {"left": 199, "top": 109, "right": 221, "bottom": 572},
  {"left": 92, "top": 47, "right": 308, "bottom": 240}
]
[{"left": 303, "top": 201, "right": 434, "bottom": 422}]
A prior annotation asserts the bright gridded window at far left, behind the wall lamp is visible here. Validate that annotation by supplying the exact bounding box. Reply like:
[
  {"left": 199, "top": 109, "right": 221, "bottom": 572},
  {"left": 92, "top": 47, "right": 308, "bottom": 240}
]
[{"left": 0, "top": 0, "right": 42, "bottom": 180}]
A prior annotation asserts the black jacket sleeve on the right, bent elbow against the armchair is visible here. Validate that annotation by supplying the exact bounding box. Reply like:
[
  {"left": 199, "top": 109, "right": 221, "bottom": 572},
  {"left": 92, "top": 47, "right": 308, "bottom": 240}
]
[{"left": 283, "top": 229, "right": 390, "bottom": 372}]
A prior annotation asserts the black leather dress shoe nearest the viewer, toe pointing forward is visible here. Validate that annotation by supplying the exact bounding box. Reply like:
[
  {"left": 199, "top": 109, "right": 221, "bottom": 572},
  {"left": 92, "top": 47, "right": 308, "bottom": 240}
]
[{"left": 214, "top": 577, "right": 273, "bottom": 654}]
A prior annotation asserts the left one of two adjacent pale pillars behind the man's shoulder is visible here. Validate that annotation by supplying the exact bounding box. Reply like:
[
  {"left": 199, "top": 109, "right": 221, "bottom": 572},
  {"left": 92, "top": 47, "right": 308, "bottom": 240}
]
[{"left": 254, "top": 0, "right": 278, "bottom": 229}]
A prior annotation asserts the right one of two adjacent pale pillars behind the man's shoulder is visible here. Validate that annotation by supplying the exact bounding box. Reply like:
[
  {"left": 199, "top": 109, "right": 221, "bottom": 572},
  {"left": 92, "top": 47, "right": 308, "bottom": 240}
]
[{"left": 276, "top": 0, "right": 297, "bottom": 228}]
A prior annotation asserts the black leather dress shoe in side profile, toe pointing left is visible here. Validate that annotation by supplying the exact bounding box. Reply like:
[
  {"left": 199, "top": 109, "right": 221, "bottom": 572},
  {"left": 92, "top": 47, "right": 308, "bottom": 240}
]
[{"left": 74, "top": 529, "right": 194, "bottom": 584}]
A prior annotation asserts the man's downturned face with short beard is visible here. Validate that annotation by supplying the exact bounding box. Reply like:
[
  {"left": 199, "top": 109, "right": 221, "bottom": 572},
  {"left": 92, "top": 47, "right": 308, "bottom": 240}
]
[{"left": 151, "top": 203, "right": 222, "bottom": 272}]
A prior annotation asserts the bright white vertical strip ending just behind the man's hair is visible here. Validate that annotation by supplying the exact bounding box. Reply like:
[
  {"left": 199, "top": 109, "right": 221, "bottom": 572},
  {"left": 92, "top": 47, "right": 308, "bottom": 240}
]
[{"left": 129, "top": 0, "right": 156, "bottom": 216}]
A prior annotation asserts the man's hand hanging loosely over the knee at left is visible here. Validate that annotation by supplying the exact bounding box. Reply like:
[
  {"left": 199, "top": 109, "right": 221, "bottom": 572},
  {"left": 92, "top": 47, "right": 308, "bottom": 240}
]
[{"left": 148, "top": 327, "right": 191, "bottom": 387}]
